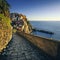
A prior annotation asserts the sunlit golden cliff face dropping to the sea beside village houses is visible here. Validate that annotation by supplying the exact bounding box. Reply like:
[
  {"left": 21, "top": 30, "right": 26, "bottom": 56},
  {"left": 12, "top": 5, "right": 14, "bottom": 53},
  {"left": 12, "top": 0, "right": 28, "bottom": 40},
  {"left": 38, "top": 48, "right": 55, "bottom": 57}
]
[{"left": 21, "top": 15, "right": 32, "bottom": 34}]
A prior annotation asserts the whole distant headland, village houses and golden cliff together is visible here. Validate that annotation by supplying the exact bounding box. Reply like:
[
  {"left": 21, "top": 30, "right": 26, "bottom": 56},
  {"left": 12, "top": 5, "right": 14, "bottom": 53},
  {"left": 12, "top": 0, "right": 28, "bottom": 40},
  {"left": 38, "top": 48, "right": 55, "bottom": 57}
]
[{"left": 10, "top": 13, "right": 32, "bottom": 33}]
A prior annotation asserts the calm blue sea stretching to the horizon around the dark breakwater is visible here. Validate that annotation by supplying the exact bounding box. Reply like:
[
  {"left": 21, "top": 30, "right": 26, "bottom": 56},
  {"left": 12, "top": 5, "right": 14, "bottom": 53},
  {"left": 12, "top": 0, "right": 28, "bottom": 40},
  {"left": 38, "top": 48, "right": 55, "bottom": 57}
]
[{"left": 30, "top": 20, "right": 60, "bottom": 41}]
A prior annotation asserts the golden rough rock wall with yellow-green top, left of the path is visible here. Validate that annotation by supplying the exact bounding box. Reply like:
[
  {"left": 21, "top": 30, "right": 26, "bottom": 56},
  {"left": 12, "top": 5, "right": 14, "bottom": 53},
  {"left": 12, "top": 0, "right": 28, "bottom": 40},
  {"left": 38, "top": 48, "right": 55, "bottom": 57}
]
[{"left": 0, "top": 14, "right": 12, "bottom": 52}]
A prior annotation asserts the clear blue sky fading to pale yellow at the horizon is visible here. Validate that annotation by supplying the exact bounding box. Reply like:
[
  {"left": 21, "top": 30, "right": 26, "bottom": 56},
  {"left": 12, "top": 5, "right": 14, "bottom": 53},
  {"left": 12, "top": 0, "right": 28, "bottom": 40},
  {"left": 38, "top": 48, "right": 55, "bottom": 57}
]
[{"left": 7, "top": 0, "right": 60, "bottom": 21}]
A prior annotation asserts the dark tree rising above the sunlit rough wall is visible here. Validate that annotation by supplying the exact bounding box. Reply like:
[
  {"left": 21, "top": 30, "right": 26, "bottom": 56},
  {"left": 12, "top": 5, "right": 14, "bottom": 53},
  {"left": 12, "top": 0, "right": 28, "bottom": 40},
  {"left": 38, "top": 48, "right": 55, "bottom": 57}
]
[{"left": 0, "top": 0, "right": 10, "bottom": 17}]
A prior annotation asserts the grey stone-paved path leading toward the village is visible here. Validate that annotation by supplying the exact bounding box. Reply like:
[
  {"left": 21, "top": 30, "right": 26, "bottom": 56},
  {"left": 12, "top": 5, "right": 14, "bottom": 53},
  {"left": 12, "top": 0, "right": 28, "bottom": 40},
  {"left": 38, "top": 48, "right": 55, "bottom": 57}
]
[{"left": 0, "top": 34, "right": 53, "bottom": 60}]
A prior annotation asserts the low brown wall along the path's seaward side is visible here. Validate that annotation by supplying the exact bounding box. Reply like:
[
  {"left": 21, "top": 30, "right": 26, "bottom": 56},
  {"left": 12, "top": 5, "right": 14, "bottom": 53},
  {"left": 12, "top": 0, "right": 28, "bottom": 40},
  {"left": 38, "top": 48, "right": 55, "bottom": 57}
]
[{"left": 17, "top": 31, "right": 60, "bottom": 57}]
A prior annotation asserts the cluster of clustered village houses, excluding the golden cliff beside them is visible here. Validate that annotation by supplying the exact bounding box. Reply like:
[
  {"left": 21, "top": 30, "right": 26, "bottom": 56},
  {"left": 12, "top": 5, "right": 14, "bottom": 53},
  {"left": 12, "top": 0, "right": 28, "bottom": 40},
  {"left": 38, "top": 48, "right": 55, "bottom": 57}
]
[{"left": 10, "top": 13, "right": 24, "bottom": 28}]
